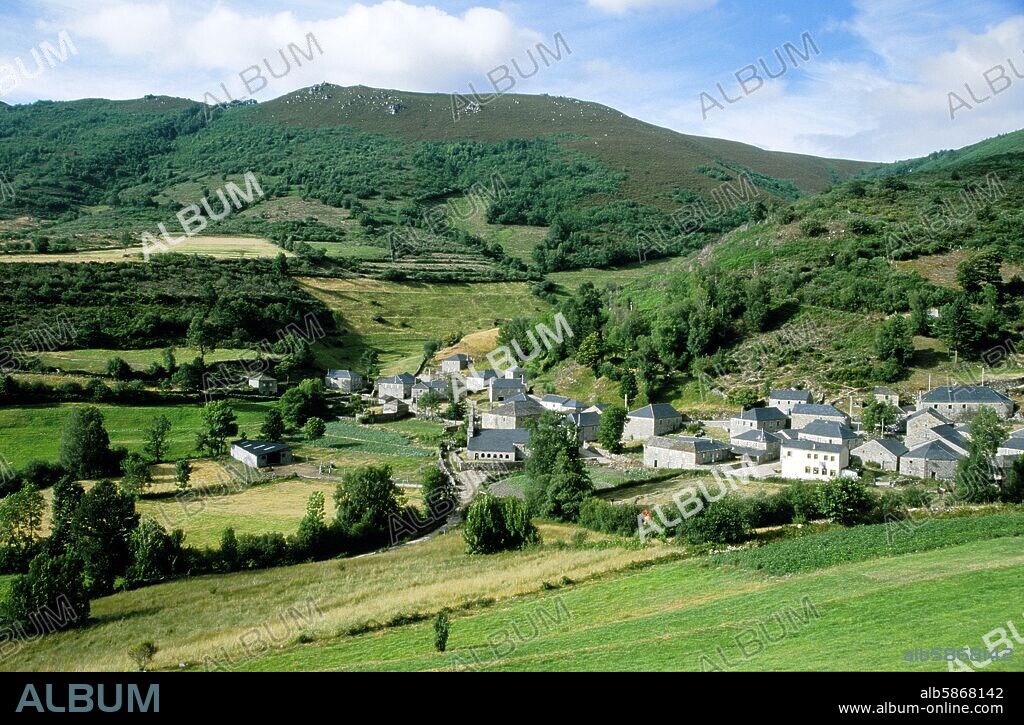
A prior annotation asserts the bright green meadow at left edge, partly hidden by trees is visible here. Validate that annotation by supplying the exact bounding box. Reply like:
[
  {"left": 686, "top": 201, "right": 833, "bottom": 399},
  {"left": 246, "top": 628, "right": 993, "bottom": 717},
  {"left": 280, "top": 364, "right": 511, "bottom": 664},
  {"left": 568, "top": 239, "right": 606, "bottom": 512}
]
[{"left": 0, "top": 401, "right": 271, "bottom": 468}]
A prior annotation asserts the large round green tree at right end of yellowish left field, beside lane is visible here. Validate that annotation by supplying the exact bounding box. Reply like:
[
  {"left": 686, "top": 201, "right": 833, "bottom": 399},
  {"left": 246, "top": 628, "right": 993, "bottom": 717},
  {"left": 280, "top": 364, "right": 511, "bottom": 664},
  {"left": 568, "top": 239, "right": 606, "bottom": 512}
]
[{"left": 334, "top": 466, "right": 404, "bottom": 544}]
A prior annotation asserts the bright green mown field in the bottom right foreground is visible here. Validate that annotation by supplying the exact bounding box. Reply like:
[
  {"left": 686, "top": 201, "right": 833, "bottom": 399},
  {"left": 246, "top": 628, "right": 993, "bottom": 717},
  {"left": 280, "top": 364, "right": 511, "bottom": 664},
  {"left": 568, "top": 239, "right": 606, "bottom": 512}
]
[{"left": 226, "top": 539, "right": 1024, "bottom": 672}]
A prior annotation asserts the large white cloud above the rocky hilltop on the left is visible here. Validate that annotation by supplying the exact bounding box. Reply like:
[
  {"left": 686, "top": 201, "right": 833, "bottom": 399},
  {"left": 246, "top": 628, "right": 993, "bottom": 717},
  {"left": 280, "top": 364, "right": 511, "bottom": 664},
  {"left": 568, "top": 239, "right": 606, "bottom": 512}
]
[{"left": 8, "top": 0, "right": 554, "bottom": 99}]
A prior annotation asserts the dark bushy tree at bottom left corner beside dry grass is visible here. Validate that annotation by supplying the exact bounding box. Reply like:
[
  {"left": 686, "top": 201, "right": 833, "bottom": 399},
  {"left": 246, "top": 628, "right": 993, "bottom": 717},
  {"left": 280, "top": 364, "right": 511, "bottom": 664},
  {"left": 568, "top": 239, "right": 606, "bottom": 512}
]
[{"left": 0, "top": 552, "right": 89, "bottom": 635}]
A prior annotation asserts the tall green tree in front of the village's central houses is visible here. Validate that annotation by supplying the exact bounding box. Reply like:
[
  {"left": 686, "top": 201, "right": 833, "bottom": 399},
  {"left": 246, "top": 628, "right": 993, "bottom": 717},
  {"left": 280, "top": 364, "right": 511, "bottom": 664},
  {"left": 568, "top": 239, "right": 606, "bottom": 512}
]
[{"left": 526, "top": 411, "right": 594, "bottom": 521}]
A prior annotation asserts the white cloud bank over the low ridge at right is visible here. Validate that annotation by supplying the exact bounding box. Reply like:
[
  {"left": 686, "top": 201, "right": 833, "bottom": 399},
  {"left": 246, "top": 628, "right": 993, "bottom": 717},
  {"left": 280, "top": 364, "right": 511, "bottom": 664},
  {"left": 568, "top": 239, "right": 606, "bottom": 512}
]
[{"left": 647, "top": 13, "right": 1024, "bottom": 161}]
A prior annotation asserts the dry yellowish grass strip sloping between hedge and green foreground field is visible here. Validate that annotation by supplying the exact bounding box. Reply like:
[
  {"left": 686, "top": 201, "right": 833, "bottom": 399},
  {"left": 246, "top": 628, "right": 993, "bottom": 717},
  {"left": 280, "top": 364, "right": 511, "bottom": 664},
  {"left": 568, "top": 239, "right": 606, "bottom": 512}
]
[{"left": 0, "top": 525, "right": 674, "bottom": 671}]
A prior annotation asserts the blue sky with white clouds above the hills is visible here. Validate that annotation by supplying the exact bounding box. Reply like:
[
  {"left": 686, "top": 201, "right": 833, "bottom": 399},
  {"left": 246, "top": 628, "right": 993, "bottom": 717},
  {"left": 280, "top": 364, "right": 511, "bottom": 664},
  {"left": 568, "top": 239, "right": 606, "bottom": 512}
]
[{"left": 0, "top": 0, "right": 1024, "bottom": 162}]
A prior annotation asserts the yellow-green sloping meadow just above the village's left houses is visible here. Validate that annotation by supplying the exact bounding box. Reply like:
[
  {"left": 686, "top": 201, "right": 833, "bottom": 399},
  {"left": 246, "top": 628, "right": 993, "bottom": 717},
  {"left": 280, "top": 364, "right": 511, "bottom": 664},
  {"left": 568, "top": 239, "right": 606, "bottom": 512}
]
[{"left": 299, "top": 278, "right": 547, "bottom": 374}]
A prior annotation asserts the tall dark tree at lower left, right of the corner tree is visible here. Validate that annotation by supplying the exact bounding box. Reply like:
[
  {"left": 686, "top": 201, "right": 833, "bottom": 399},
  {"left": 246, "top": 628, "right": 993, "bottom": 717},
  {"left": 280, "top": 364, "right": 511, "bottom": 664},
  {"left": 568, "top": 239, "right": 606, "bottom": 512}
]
[{"left": 70, "top": 480, "right": 138, "bottom": 596}]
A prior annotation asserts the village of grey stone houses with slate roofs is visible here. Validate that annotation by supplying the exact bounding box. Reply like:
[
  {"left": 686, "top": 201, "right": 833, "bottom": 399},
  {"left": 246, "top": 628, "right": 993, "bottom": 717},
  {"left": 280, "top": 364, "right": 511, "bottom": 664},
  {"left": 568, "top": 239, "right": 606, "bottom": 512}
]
[{"left": 231, "top": 353, "right": 1024, "bottom": 493}]
